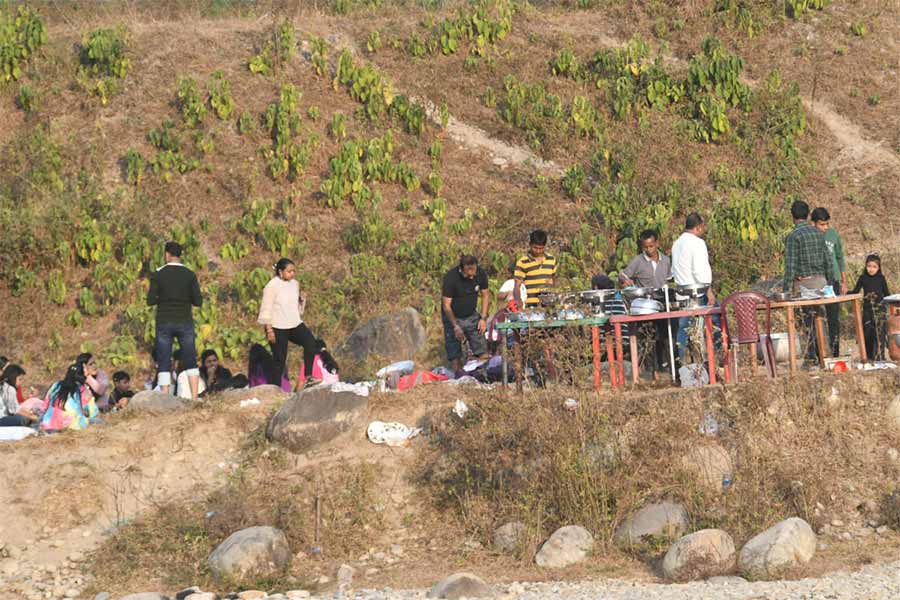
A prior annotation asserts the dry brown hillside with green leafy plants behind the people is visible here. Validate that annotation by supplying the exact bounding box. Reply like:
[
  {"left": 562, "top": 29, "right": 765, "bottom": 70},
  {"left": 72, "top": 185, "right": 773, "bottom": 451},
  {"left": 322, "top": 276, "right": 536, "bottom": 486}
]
[{"left": 0, "top": 0, "right": 900, "bottom": 381}]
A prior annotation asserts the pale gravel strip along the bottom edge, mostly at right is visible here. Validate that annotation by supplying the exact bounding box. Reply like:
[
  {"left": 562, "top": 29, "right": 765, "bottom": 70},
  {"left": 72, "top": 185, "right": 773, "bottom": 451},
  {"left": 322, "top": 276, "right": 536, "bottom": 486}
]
[{"left": 329, "top": 562, "right": 900, "bottom": 600}]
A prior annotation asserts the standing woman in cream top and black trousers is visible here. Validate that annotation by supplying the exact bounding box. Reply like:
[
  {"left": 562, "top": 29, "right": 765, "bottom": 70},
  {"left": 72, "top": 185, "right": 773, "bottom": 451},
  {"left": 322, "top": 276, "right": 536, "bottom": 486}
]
[{"left": 258, "top": 258, "right": 322, "bottom": 387}]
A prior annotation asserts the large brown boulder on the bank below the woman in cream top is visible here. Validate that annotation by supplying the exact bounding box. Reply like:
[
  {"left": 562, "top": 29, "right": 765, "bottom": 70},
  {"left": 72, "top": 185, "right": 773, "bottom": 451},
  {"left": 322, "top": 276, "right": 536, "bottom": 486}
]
[{"left": 266, "top": 387, "right": 369, "bottom": 452}]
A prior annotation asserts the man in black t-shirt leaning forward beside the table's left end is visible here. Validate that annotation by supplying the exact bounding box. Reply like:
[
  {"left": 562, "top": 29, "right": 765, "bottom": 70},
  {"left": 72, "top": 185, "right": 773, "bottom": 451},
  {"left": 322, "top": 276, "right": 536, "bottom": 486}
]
[{"left": 441, "top": 255, "right": 490, "bottom": 370}]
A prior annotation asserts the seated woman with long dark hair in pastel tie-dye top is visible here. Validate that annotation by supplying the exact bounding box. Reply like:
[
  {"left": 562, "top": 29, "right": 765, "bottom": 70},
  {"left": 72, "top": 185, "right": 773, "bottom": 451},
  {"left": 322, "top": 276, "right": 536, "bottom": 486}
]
[{"left": 41, "top": 362, "right": 100, "bottom": 431}]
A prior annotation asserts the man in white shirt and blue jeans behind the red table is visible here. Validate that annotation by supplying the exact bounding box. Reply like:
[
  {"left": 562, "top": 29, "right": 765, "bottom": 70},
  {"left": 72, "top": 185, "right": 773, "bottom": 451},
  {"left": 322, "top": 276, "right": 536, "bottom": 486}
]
[{"left": 672, "top": 212, "right": 719, "bottom": 364}]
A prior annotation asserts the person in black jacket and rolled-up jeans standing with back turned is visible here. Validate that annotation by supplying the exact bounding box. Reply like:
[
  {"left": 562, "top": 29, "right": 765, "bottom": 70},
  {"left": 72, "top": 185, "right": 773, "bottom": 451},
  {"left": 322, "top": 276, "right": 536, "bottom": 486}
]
[{"left": 147, "top": 242, "right": 203, "bottom": 401}]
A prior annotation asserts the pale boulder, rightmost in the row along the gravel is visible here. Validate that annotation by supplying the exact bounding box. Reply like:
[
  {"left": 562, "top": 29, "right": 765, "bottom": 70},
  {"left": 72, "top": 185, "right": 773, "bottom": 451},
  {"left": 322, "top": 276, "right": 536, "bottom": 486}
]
[{"left": 738, "top": 517, "right": 816, "bottom": 579}]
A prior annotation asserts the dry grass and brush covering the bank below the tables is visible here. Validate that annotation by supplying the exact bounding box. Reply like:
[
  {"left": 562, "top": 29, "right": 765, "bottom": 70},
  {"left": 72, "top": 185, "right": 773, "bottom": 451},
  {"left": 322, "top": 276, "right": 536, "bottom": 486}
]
[{"left": 418, "top": 374, "right": 900, "bottom": 572}]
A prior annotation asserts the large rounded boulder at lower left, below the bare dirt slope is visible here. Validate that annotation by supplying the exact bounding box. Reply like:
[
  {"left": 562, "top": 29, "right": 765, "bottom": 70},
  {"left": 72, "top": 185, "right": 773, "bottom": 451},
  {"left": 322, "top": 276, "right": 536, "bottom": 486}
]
[{"left": 206, "top": 527, "right": 291, "bottom": 581}]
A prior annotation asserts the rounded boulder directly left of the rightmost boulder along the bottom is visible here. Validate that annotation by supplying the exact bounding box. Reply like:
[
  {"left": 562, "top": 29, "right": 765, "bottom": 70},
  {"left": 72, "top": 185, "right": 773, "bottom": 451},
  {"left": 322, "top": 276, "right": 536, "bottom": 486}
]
[{"left": 662, "top": 529, "right": 734, "bottom": 581}]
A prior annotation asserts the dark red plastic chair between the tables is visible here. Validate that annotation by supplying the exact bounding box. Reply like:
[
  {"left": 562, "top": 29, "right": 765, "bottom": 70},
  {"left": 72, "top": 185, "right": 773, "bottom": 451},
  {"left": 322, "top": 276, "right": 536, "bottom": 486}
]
[{"left": 722, "top": 292, "right": 775, "bottom": 381}]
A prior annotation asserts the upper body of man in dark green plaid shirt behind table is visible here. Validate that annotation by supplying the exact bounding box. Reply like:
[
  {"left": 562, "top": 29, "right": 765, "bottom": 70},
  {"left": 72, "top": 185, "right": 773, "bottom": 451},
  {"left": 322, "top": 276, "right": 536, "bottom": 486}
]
[{"left": 783, "top": 200, "right": 837, "bottom": 292}]
